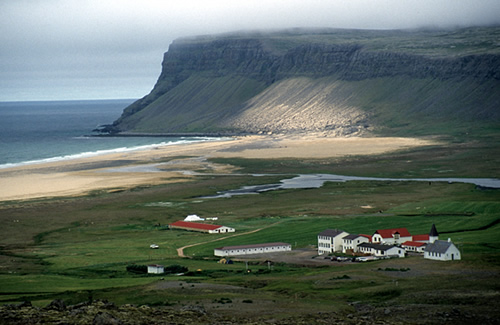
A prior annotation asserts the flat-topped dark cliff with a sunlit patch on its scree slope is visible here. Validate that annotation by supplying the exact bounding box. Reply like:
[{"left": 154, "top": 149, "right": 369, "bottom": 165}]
[{"left": 107, "top": 27, "right": 500, "bottom": 136}]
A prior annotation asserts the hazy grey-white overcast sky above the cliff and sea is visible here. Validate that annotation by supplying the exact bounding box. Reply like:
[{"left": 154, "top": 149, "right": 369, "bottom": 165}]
[{"left": 0, "top": 0, "right": 500, "bottom": 101}]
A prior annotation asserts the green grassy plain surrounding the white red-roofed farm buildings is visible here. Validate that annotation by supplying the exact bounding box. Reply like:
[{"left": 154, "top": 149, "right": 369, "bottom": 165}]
[{"left": 0, "top": 139, "right": 500, "bottom": 323}]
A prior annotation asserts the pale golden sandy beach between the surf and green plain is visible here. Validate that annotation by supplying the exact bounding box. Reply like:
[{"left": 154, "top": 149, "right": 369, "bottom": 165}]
[{"left": 0, "top": 135, "right": 435, "bottom": 201}]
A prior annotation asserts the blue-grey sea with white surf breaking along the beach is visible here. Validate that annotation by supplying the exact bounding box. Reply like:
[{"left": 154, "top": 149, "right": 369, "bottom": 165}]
[{"left": 0, "top": 99, "right": 221, "bottom": 168}]
